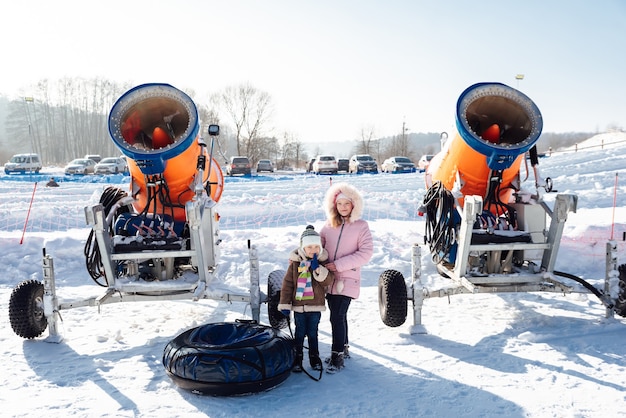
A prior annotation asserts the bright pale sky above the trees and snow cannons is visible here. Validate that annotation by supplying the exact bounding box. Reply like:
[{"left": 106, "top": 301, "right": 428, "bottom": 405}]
[{"left": 0, "top": 0, "right": 626, "bottom": 142}]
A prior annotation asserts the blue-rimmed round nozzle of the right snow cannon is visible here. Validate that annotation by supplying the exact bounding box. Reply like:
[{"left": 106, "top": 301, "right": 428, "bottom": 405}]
[{"left": 456, "top": 83, "right": 543, "bottom": 170}]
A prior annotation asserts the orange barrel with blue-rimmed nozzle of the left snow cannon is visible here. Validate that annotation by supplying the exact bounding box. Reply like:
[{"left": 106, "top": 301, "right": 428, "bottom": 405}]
[{"left": 109, "top": 83, "right": 224, "bottom": 221}]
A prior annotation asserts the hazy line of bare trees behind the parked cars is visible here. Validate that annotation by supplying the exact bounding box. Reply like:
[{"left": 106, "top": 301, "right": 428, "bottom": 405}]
[{"left": 0, "top": 79, "right": 596, "bottom": 168}]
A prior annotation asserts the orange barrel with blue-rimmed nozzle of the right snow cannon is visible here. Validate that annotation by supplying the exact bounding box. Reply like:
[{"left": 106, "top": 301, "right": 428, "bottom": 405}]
[{"left": 425, "top": 83, "right": 543, "bottom": 212}]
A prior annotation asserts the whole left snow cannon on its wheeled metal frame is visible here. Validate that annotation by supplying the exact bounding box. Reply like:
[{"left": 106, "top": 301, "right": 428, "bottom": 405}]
[{"left": 9, "top": 84, "right": 272, "bottom": 344}]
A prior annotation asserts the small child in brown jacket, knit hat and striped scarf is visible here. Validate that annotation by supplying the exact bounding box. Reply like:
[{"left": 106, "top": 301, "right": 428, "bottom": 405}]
[{"left": 278, "top": 225, "right": 333, "bottom": 372}]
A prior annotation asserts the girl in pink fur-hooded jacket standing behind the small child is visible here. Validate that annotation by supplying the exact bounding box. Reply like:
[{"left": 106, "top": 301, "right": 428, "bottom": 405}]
[{"left": 320, "top": 183, "right": 374, "bottom": 373}]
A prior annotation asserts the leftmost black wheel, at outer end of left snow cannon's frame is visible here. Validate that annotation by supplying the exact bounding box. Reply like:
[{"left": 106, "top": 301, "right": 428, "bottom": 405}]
[{"left": 9, "top": 280, "right": 48, "bottom": 338}]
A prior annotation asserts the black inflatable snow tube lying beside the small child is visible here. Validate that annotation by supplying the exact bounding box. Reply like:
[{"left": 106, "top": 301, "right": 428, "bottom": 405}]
[{"left": 163, "top": 322, "right": 295, "bottom": 396}]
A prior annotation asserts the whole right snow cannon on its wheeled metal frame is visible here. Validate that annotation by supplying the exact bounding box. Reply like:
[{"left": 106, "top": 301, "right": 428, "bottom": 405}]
[{"left": 370, "top": 83, "right": 626, "bottom": 334}]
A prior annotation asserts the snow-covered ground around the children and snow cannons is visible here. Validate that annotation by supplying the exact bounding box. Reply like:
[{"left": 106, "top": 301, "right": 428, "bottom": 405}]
[{"left": 0, "top": 134, "right": 626, "bottom": 417}]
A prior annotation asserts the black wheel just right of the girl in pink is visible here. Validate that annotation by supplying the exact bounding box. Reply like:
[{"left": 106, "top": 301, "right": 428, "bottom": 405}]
[{"left": 378, "top": 270, "right": 407, "bottom": 327}]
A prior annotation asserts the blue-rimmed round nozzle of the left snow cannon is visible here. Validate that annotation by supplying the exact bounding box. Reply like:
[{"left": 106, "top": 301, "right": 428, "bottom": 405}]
[{"left": 109, "top": 83, "right": 200, "bottom": 175}]
